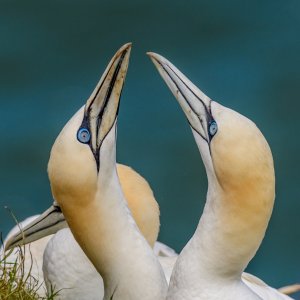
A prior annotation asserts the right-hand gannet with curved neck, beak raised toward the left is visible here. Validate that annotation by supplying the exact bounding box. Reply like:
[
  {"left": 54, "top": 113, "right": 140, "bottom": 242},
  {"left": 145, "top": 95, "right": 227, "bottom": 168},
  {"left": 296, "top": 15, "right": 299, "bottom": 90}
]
[{"left": 148, "top": 52, "right": 291, "bottom": 300}]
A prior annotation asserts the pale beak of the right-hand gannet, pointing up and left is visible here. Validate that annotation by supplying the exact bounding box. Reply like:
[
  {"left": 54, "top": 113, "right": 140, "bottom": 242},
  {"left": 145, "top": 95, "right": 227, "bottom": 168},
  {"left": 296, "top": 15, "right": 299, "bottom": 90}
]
[{"left": 147, "top": 52, "right": 214, "bottom": 143}]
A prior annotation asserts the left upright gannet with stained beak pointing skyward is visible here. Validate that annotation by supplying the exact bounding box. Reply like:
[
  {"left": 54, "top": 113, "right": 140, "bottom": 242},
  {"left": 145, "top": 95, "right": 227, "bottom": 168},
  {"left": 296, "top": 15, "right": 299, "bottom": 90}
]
[{"left": 5, "top": 44, "right": 167, "bottom": 300}]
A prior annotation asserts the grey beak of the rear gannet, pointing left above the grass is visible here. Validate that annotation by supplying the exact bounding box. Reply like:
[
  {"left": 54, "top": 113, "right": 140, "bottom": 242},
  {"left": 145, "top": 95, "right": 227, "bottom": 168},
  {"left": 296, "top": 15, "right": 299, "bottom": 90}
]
[{"left": 4, "top": 203, "right": 68, "bottom": 251}]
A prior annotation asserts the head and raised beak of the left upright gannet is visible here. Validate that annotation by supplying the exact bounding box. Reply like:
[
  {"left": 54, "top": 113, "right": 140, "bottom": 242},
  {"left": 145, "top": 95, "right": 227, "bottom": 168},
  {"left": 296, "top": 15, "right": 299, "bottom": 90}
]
[{"left": 48, "top": 44, "right": 131, "bottom": 213}]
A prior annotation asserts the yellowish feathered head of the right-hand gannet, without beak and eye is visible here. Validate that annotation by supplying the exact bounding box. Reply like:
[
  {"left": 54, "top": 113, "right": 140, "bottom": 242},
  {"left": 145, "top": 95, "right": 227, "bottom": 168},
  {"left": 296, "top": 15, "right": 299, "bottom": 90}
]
[{"left": 211, "top": 103, "right": 275, "bottom": 218}]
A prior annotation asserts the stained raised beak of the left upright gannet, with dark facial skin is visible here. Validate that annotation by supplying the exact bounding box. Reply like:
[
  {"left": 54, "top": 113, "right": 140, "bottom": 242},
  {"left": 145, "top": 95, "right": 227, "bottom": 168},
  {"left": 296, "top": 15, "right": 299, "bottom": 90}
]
[{"left": 81, "top": 43, "right": 131, "bottom": 170}]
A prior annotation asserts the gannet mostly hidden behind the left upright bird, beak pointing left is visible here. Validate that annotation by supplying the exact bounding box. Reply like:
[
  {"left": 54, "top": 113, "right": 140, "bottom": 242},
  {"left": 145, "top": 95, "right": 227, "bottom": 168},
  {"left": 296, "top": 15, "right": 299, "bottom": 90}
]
[{"left": 4, "top": 164, "right": 177, "bottom": 300}]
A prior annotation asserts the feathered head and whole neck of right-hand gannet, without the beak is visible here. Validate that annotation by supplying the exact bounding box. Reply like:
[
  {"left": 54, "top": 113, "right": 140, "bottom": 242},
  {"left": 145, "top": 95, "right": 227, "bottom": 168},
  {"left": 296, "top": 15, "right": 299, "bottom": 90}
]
[{"left": 169, "top": 108, "right": 275, "bottom": 299}]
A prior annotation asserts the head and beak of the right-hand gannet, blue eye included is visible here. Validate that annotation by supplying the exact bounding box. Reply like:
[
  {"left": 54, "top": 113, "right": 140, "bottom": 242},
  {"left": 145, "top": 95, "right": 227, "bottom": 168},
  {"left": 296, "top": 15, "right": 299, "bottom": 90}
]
[{"left": 149, "top": 53, "right": 275, "bottom": 201}]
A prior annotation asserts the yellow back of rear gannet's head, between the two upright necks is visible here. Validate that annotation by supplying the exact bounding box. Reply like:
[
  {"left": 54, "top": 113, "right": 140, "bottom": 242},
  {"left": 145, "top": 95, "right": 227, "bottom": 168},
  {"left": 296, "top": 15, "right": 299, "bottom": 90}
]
[{"left": 117, "top": 164, "right": 160, "bottom": 247}]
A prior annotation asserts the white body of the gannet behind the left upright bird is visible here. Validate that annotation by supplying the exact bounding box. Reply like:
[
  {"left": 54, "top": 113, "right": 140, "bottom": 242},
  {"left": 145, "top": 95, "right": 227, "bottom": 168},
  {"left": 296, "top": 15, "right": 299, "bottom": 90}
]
[{"left": 43, "top": 228, "right": 177, "bottom": 300}]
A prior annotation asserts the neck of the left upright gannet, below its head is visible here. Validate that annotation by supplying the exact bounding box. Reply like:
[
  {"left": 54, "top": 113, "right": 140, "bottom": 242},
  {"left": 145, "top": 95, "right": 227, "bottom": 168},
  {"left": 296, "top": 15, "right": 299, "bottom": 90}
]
[{"left": 56, "top": 126, "right": 167, "bottom": 299}]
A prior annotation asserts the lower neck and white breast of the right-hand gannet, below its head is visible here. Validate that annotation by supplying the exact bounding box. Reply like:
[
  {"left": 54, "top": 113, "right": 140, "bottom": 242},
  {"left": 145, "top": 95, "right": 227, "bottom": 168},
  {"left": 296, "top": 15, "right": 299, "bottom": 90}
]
[{"left": 167, "top": 179, "right": 270, "bottom": 300}]
